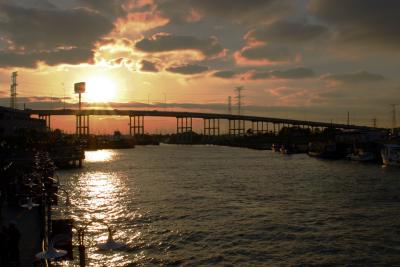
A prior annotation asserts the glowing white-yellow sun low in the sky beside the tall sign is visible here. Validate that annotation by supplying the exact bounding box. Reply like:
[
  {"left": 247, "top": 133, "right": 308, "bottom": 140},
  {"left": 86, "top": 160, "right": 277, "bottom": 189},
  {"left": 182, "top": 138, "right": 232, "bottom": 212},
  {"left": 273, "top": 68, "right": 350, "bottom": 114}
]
[{"left": 85, "top": 76, "right": 116, "bottom": 102}]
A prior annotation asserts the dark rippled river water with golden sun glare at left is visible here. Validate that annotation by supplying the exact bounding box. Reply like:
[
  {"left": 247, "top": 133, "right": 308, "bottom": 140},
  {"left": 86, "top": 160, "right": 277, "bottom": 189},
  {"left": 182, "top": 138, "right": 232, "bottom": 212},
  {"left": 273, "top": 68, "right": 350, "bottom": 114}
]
[{"left": 55, "top": 145, "right": 400, "bottom": 266}]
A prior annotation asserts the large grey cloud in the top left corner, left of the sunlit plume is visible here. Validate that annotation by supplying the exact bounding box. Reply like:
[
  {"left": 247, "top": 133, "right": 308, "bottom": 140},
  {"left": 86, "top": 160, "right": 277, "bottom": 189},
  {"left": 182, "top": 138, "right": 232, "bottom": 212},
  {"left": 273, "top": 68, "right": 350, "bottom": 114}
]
[{"left": 0, "top": 1, "right": 113, "bottom": 67}]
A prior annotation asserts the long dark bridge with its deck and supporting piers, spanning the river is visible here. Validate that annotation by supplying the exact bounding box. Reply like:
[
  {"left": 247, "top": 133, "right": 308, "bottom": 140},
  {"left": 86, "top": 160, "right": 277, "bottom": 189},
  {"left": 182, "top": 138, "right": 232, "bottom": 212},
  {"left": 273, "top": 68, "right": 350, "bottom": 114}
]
[{"left": 26, "top": 109, "right": 375, "bottom": 136}]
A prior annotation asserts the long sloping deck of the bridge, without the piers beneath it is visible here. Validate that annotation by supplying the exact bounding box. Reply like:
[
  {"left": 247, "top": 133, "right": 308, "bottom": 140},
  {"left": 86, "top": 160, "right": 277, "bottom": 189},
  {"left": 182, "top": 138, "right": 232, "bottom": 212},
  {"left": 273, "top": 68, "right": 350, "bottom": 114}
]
[{"left": 27, "top": 109, "right": 376, "bottom": 130}]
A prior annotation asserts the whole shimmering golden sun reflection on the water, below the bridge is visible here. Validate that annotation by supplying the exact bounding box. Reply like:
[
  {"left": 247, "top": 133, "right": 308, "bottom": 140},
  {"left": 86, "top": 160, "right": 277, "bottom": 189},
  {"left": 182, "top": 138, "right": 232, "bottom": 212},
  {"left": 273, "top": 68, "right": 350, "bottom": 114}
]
[{"left": 55, "top": 150, "right": 145, "bottom": 266}]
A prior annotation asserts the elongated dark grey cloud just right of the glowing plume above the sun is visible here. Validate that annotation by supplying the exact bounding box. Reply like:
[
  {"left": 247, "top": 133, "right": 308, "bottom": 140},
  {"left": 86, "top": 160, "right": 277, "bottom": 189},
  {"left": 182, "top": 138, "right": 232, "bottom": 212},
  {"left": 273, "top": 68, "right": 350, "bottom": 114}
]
[{"left": 135, "top": 34, "right": 223, "bottom": 56}]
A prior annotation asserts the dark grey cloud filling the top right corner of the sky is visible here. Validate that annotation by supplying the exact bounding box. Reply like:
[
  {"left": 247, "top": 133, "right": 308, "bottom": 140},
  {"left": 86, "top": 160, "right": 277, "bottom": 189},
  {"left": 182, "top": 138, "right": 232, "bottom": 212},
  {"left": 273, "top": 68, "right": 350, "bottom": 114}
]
[{"left": 309, "top": 0, "right": 400, "bottom": 50}]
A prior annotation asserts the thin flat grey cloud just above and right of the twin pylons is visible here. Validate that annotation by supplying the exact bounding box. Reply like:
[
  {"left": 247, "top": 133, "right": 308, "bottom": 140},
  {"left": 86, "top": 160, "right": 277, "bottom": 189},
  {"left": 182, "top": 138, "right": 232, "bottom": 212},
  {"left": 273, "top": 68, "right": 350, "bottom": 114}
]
[{"left": 250, "top": 67, "right": 315, "bottom": 80}]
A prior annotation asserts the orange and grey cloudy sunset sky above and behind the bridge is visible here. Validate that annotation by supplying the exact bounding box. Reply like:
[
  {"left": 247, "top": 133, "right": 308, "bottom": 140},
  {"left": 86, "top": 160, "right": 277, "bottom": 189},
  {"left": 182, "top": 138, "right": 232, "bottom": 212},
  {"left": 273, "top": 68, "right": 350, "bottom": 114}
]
[{"left": 0, "top": 0, "right": 400, "bottom": 131}]
